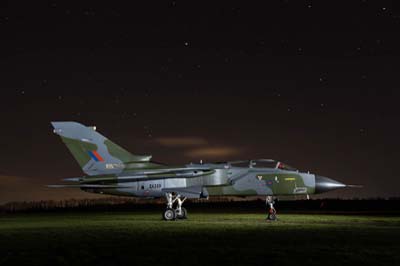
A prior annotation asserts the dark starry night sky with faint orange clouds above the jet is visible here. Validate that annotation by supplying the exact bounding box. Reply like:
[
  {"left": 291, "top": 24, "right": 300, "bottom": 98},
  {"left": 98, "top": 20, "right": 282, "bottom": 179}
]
[{"left": 0, "top": 0, "right": 400, "bottom": 202}]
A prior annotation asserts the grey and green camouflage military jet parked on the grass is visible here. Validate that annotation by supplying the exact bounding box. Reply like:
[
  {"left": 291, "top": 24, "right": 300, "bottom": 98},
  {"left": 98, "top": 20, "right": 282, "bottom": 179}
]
[{"left": 50, "top": 122, "right": 356, "bottom": 220}]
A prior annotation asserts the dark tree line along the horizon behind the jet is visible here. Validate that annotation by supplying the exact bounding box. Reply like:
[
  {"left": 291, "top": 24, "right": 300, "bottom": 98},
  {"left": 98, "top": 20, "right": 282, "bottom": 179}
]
[{"left": 0, "top": 197, "right": 400, "bottom": 214}]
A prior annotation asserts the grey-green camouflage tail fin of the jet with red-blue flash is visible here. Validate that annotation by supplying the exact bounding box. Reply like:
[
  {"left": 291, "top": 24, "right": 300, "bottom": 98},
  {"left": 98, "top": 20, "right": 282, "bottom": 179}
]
[{"left": 51, "top": 122, "right": 156, "bottom": 175}]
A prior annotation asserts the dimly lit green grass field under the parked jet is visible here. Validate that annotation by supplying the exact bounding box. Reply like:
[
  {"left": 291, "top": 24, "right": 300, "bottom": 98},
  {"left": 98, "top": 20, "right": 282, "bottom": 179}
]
[{"left": 0, "top": 212, "right": 400, "bottom": 265}]
